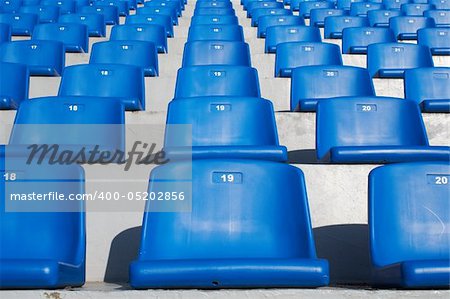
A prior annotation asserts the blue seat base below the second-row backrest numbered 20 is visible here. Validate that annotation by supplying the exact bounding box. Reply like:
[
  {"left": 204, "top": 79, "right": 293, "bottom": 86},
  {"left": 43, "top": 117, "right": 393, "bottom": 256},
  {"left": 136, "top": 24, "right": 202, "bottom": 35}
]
[{"left": 330, "top": 146, "right": 450, "bottom": 164}]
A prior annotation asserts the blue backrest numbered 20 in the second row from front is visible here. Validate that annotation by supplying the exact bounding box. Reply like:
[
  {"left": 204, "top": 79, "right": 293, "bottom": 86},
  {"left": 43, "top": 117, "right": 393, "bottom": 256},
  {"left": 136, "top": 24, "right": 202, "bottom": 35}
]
[{"left": 316, "top": 97, "right": 428, "bottom": 159}]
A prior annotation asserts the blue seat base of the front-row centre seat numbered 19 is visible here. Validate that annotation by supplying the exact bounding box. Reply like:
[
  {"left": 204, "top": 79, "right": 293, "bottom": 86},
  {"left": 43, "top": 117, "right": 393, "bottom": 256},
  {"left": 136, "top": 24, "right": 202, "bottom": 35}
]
[{"left": 130, "top": 258, "right": 329, "bottom": 289}]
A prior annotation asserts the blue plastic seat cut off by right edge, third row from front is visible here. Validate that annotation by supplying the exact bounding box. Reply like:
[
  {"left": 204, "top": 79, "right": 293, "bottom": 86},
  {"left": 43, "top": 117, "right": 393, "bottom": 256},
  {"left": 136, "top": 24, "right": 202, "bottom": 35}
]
[{"left": 405, "top": 67, "right": 450, "bottom": 113}]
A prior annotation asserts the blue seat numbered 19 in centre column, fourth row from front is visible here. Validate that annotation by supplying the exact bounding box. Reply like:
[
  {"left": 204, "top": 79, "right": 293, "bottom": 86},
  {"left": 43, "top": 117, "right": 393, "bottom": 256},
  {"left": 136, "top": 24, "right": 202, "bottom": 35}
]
[{"left": 183, "top": 40, "right": 251, "bottom": 67}]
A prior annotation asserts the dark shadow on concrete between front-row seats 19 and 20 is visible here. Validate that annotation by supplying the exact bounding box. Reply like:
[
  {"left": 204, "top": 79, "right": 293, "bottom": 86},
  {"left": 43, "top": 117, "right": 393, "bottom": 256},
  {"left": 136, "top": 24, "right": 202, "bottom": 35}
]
[{"left": 313, "top": 224, "right": 374, "bottom": 286}]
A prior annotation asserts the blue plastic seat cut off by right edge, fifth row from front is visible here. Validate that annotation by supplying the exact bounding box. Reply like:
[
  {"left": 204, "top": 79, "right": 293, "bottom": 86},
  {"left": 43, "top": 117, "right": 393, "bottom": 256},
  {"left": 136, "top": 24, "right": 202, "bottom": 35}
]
[{"left": 417, "top": 28, "right": 450, "bottom": 55}]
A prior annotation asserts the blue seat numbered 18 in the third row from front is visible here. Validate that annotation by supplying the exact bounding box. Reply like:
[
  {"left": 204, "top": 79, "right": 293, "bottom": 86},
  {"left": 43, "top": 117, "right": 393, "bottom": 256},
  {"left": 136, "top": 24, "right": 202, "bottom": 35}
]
[{"left": 58, "top": 64, "right": 145, "bottom": 110}]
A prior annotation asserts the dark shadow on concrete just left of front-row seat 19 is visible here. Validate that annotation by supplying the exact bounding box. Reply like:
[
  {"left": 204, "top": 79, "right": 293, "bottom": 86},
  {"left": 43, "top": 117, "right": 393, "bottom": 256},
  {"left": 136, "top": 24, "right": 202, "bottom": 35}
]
[{"left": 103, "top": 226, "right": 141, "bottom": 284}]
